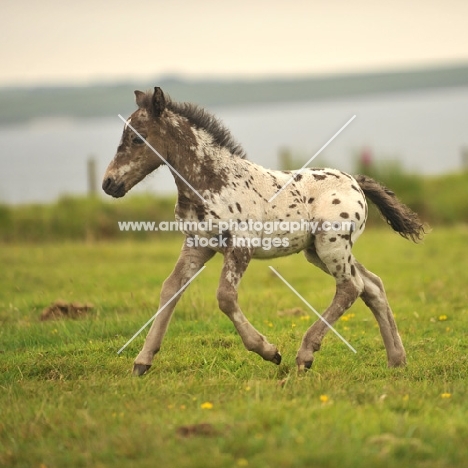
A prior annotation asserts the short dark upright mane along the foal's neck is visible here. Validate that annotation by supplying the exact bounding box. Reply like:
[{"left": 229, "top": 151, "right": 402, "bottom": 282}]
[{"left": 165, "top": 94, "right": 247, "bottom": 159}]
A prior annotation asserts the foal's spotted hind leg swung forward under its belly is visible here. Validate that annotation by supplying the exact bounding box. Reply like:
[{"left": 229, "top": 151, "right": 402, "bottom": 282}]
[{"left": 296, "top": 232, "right": 364, "bottom": 370}]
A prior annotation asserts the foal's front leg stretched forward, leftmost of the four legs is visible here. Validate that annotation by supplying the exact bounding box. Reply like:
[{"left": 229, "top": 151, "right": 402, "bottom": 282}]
[{"left": 133, "top": 243, "right": 215, "bottom": 376}]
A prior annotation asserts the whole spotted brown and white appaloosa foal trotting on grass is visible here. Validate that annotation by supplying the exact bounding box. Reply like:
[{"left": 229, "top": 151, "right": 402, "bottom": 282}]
[{"left": 102, "top": 88, "right": 424, "bottom": 375}]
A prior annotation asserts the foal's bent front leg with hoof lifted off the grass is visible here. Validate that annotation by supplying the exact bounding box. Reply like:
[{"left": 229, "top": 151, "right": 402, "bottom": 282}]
[{"left": 217, "top": 248, "right": 281, "bottom": 364}]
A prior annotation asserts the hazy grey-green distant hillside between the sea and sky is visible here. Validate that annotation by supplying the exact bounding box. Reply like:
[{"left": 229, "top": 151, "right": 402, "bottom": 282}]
[{"left": 0, "top": 65, "right": 468, "bottom": 125}]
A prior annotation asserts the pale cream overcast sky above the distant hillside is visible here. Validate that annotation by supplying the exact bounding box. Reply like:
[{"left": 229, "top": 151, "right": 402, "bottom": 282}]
[{"left": 0, "top": 0, "right": 468, "bottom": 86}]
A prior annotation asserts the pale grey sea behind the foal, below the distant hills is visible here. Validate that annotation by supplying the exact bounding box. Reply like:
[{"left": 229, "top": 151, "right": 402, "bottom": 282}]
[{"left": 0, "top": 87, "right": 468, "bottom": 204}]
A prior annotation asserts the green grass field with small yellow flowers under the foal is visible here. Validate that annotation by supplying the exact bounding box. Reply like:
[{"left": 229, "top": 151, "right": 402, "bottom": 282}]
[{"left": 0, "top": 227, "right": 468, "bottom": 468}]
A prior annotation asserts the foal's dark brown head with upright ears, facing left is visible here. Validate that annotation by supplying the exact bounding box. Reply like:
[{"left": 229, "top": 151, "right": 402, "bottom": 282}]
[{"left": 102, "top": 88, "right": 166, "bottom": 198}]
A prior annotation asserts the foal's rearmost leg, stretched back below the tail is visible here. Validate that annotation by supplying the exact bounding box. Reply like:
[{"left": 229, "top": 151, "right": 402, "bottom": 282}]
[{"left": 356, "top": 262, "right": 406, "bottom": 367}]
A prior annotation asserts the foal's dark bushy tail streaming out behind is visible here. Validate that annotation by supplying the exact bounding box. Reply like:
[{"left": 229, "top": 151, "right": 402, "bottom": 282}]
[{"left": 354, "top": 175, "right": 425, "bottom": 242}]
